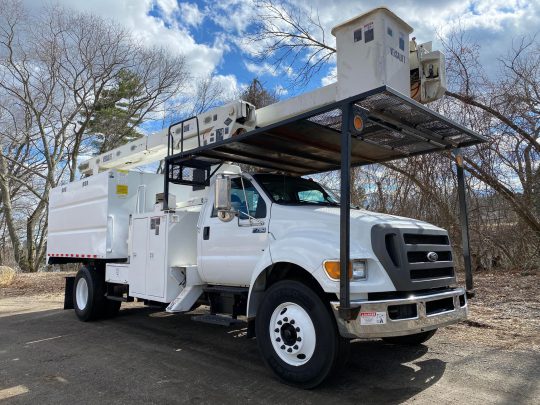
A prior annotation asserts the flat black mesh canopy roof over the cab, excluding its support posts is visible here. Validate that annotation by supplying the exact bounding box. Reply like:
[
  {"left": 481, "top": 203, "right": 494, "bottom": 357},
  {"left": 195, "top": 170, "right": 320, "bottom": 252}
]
[{"left": 168, "top": 86, "right": 485, "bottom": 176}]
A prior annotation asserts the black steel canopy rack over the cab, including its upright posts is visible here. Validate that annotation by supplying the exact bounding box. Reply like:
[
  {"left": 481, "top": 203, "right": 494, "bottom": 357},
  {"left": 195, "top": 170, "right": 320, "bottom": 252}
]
[{"left": 164, "top": 86, "right": 486, "bottom": 320}]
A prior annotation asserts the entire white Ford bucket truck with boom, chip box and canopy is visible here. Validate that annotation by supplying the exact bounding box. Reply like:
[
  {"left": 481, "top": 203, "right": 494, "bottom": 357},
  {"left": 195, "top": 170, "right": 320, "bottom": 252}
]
[{"left": 48, "top": 8, "right": 482, "bottom": 387}]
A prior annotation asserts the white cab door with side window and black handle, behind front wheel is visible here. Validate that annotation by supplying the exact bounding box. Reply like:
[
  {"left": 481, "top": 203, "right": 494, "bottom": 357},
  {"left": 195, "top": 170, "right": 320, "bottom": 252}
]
[{"left": 199, "top": 177, "right": 270, "bottom": 286}]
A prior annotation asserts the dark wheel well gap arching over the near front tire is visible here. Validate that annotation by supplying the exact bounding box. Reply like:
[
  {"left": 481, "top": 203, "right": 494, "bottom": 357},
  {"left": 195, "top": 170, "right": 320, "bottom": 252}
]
[{"left": 248, "top": 262, "right": 336, "bottom": 318}]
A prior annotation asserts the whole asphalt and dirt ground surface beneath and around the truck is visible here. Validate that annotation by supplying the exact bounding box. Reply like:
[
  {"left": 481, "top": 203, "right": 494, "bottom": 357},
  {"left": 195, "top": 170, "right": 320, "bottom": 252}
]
[{"left": 0, "top": 272, "right": 540, "bottom": 404}]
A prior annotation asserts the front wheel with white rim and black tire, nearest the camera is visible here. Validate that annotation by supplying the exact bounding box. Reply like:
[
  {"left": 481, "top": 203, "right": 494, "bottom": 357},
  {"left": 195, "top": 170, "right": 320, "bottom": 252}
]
[{"left": 255, "top": 280, "right": 348, "bottom": 388}]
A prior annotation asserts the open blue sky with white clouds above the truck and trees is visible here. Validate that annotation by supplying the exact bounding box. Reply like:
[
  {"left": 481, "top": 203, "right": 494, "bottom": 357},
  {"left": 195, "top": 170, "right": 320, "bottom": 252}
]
[{"left": 23, "top": 0, "right": 540, "bottom": 129}]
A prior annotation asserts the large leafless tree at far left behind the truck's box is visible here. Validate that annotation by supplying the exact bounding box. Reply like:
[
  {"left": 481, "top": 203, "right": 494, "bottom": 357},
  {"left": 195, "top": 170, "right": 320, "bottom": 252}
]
[{"left": 0, "top": 0, "right": 187, "bottom": 271}]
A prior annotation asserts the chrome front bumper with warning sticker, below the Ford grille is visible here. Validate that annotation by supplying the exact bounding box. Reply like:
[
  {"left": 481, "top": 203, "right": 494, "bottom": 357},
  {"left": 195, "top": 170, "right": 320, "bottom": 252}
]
[{"left": 330, "top": 288, "right": 468, "bottom": 338}]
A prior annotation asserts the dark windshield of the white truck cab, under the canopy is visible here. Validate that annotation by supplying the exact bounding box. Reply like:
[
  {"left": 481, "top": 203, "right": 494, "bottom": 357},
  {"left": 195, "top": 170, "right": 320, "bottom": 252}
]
[{"left": 254, "top": 174, "right": 339, "bottom": 206}]
